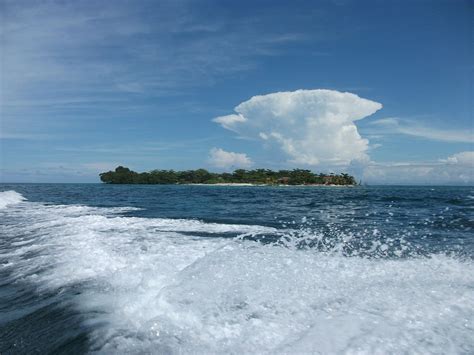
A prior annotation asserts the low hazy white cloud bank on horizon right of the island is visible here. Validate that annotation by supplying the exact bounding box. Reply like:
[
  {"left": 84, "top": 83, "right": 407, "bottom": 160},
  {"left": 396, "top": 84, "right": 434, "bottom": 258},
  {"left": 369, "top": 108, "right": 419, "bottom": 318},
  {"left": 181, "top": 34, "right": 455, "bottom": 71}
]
[{"left": 362, "top": 151, "right": 474, "bottom": 185}]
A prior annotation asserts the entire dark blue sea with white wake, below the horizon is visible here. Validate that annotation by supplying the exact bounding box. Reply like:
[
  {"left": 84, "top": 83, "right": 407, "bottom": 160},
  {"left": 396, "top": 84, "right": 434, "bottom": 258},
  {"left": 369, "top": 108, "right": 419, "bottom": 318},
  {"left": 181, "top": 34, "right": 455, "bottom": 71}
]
[{"left": 0, "top": 184, "right": 474, "bottom": 354}]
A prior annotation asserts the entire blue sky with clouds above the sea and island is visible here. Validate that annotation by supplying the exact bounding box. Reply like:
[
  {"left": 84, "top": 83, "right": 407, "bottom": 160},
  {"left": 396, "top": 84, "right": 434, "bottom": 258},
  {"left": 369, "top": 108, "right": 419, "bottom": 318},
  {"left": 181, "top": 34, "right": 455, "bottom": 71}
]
[{"left": 0, "top": 0, "right": 474, "bottom": 185}]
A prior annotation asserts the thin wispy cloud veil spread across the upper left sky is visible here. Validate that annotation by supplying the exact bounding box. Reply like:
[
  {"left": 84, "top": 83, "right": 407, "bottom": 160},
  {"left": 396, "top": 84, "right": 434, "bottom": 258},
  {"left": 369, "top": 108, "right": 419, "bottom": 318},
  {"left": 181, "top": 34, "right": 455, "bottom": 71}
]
[{"left": 0, "top": 0, "right": 307, "bottom": 119}]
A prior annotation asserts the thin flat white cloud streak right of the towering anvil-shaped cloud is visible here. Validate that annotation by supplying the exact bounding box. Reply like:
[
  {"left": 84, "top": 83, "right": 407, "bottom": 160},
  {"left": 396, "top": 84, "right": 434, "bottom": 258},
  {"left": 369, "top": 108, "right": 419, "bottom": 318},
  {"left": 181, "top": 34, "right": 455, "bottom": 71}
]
[{"left": 372, "top": 117, "right": 474, "bottom": 143}]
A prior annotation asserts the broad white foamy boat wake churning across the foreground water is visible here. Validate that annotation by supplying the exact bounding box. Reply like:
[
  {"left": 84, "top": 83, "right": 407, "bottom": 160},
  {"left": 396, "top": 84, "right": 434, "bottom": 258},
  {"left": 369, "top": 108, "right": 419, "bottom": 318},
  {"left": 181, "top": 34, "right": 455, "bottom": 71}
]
[{"left": 0, "top": 196, "right": 474, "bottom": 354}]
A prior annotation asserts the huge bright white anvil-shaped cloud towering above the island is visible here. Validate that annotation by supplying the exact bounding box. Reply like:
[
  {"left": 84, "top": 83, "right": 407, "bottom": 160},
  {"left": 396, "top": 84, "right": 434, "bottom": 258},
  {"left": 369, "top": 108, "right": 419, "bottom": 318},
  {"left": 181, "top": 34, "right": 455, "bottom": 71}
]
[{"left": 213, "top": 90, "right": 382, "bottom": 165}]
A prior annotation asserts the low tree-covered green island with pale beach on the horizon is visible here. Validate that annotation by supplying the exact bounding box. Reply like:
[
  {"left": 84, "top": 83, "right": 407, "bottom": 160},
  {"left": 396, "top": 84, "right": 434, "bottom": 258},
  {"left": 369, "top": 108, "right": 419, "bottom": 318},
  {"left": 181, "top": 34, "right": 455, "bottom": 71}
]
[{"left": 99, "top": 166, "right": 357, "bottom": 186}]
